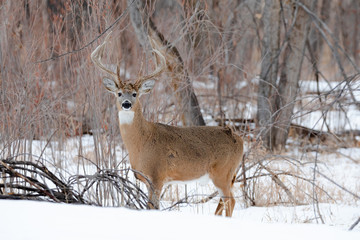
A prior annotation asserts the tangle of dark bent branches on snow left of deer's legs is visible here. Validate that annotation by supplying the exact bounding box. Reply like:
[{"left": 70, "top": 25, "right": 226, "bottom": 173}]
[{"left": 0, "top": 157, "right": 148, "bottom": 209}]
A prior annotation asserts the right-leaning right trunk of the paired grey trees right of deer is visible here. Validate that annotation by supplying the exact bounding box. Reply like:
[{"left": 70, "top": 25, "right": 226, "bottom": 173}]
[{"left": 270, "top": 0, "right": 315, "bottom": 150}]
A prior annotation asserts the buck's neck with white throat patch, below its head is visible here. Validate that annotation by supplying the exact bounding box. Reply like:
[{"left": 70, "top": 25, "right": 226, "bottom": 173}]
[{"left": 118, "top": 102, "right": 151, "bottom": 152}]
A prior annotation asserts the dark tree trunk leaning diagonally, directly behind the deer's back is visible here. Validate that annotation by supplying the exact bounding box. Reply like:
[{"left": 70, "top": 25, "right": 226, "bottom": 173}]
[{"left": 128, "top": 0, "right": 205, "bottom": 126}]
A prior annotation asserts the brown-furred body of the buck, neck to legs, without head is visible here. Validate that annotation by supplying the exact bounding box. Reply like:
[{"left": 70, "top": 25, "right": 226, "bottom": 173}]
[{"left": 118, "top": 96, "right": 243, "bottom": 216}]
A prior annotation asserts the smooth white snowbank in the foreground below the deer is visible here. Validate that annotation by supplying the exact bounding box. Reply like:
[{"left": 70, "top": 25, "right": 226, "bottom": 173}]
[{"left": 0, "top": 200, "right": 360, "bottom": 240}]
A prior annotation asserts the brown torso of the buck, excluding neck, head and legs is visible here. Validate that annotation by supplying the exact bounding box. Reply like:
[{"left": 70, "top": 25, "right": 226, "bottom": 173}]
[{"left": 137, "top": 123, "right": 243, "bottom": 181}]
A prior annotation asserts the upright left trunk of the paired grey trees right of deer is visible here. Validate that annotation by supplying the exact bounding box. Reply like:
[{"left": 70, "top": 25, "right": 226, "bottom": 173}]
[{"left": 257, "top": 0, "right": 280, "bottom": 147}]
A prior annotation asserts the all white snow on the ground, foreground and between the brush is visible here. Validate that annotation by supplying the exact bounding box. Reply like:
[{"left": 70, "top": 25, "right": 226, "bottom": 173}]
[{"left": 0, "top": 78, "right": 360, "bottom": 240}]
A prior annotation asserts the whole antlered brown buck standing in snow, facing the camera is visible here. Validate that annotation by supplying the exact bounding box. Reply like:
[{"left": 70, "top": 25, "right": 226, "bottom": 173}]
[{"left": 91, "top": 34, "right": 243, "bottom": 217}]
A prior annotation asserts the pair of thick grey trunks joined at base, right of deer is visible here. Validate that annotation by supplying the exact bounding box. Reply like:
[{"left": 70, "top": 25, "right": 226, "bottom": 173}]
[{"left": 257, "top": 0, "right": 315, "bottom": 150}]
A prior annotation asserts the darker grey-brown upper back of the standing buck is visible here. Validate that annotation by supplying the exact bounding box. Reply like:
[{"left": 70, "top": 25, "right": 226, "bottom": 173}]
[{"left": 151, "top": 123, "right": 243, "bottom": 161}]
